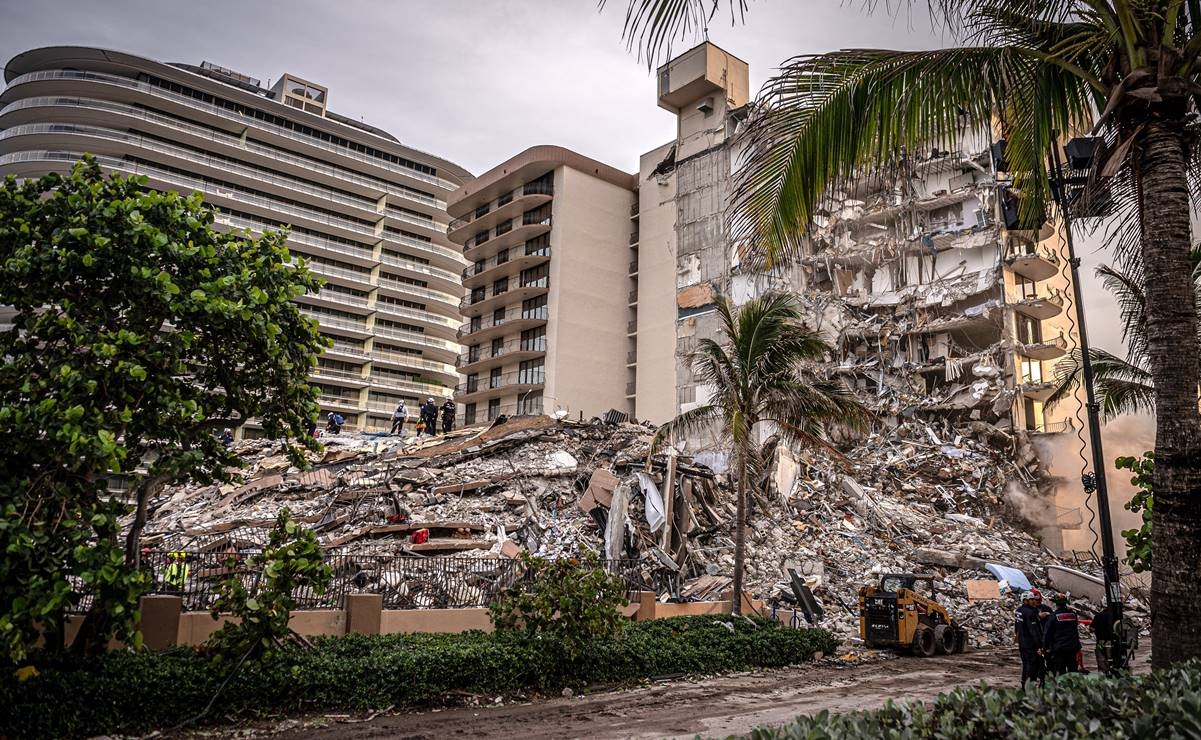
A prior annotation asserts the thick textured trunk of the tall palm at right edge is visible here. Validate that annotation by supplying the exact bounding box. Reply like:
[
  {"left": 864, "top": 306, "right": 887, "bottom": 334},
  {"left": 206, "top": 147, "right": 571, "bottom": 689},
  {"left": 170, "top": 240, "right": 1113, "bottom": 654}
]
[{"left": 1139, "top": 120, "right": 1201, "bottom": 668}]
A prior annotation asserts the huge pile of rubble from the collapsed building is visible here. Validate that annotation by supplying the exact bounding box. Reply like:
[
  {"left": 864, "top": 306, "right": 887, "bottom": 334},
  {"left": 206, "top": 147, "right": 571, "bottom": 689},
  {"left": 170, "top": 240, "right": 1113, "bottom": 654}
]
[{"left": 136, "top": 417, "right": 1119, "bottom": 644}]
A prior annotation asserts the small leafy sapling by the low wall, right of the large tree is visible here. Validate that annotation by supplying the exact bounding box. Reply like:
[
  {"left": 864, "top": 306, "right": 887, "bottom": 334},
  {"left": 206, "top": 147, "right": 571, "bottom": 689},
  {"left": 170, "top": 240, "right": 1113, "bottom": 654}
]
[{"left": 208, "top": 509, "right": 334, "bottom": 664}]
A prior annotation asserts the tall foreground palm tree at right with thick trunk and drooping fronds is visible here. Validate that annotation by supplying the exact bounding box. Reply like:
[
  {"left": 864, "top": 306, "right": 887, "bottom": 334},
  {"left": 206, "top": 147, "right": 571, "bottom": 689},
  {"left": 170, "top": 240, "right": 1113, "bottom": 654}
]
[{"left": 602, "top": 0, "right": 1201, "bottom": 667}]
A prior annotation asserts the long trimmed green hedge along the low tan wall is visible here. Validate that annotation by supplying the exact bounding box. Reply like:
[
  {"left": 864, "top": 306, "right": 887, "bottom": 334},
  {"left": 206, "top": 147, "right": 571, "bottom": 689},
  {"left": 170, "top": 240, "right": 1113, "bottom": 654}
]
[{"left": 0, "top": 616, "right": 837, "bottom": 739}]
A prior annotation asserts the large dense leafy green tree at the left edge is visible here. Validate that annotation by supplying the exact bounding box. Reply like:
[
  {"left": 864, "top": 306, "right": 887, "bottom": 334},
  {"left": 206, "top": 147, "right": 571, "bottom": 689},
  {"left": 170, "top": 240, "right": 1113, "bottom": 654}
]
[{"left": 0, "top": 157, "right": 324, "bottom": 658}]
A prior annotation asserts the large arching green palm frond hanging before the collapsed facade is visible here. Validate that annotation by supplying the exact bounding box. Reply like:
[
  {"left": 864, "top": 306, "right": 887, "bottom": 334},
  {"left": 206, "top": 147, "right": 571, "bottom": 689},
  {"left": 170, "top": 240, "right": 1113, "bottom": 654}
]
[{"left": 729, "top": 47, "right": 1092, "bottom": 264}]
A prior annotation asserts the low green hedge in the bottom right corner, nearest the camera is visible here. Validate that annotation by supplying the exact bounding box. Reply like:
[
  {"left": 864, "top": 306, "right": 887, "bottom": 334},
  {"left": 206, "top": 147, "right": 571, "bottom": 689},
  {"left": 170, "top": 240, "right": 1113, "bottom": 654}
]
[{"left": 751, "top": 661, "right": 1201, "bottom": 740}]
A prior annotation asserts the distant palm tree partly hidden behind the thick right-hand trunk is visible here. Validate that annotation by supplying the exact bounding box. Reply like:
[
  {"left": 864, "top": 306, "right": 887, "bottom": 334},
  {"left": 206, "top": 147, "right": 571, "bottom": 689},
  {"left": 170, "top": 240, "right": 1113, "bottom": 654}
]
[{"left": 1046, "top": 245, "right": 1201, "bottom": 418}]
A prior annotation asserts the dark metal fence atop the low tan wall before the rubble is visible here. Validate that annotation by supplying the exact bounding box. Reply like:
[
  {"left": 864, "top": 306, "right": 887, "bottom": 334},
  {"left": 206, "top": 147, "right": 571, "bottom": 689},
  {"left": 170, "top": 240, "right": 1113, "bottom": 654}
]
[{"left": 98, "top": 551, "right": 653, "bottom": 611}]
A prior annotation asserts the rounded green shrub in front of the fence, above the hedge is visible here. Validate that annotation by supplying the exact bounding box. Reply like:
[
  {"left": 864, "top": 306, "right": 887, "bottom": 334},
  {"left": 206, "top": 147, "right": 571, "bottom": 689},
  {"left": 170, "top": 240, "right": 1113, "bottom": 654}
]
[{"left": 489, "top": 553, "right": 629, "bottom": 658}]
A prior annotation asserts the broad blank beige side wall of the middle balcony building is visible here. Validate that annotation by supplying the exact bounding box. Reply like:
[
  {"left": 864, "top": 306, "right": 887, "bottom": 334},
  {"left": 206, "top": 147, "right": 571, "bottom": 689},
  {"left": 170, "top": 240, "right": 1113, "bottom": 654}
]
[{"left": 544, "top": 167, "right": 634, "bottom": 417}]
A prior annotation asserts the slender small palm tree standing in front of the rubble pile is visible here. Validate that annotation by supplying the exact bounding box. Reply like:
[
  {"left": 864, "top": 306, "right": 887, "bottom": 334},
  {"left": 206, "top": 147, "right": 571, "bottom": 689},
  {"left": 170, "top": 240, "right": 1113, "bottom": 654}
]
[{"left": 651, "top": 293, "right": 867, "bottom": 614}]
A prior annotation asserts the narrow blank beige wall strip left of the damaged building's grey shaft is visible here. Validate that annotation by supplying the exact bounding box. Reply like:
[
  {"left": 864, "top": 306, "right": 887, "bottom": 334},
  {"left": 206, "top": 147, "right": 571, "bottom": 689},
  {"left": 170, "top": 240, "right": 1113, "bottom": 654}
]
[{"left": 634, "top": 142, "right": 676, "bottom": 424}]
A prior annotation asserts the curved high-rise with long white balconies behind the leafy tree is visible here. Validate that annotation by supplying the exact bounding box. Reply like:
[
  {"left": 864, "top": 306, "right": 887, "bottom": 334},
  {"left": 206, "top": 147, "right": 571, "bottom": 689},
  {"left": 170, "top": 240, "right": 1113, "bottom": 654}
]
[{"left": 0, "top": 47, "right": 471, "bottom": 429}]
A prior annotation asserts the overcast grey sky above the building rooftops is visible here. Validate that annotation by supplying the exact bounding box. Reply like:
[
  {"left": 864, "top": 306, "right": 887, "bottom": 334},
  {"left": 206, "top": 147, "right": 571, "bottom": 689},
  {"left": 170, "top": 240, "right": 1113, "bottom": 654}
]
[{"left": 0, "top": 0, "right": 938, "bottom": 174}]
